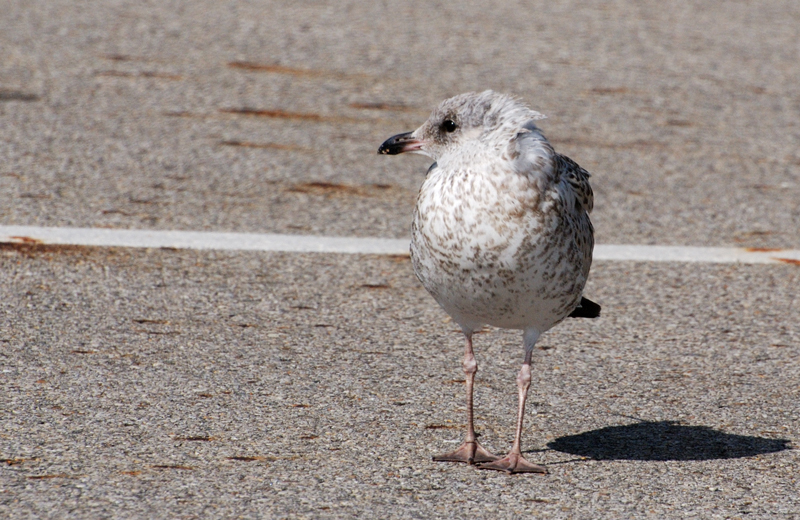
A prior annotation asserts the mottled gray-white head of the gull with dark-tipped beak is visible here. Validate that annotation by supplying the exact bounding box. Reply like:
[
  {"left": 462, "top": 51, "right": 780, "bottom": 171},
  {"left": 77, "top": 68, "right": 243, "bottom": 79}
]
[{"left": 378, "top": 90, "right": 544, "bottom": 161}]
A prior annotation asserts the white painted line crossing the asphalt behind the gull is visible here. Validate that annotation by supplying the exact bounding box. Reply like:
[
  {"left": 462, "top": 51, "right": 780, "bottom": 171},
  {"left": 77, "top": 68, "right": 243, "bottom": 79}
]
[{"left": 0, "top": 226, "right": 800, "bottom": 265}]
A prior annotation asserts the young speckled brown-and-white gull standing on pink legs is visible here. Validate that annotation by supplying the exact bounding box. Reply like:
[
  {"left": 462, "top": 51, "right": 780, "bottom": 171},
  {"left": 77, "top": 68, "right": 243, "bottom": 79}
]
[{"left": 378, "top": 90, "right": 600, "bottom": 473}]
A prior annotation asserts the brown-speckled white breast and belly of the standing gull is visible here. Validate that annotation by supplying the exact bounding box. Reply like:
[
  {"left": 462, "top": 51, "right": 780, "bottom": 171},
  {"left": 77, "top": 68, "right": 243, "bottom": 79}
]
[{"left": 411, "top": 161, "right": 588, "bottom": 330}]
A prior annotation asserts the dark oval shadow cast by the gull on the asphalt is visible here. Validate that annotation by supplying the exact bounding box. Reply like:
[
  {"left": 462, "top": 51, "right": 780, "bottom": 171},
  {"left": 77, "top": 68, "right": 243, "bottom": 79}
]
[{"left": 547, "top": 421, "right": 792, "bottom": 460}]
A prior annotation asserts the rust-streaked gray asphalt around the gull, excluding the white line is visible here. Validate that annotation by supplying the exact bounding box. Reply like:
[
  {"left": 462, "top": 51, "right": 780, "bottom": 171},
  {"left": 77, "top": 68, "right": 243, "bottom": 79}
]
[{"left": 0, "top": 0, "right": 800, "bottom": 519}]
